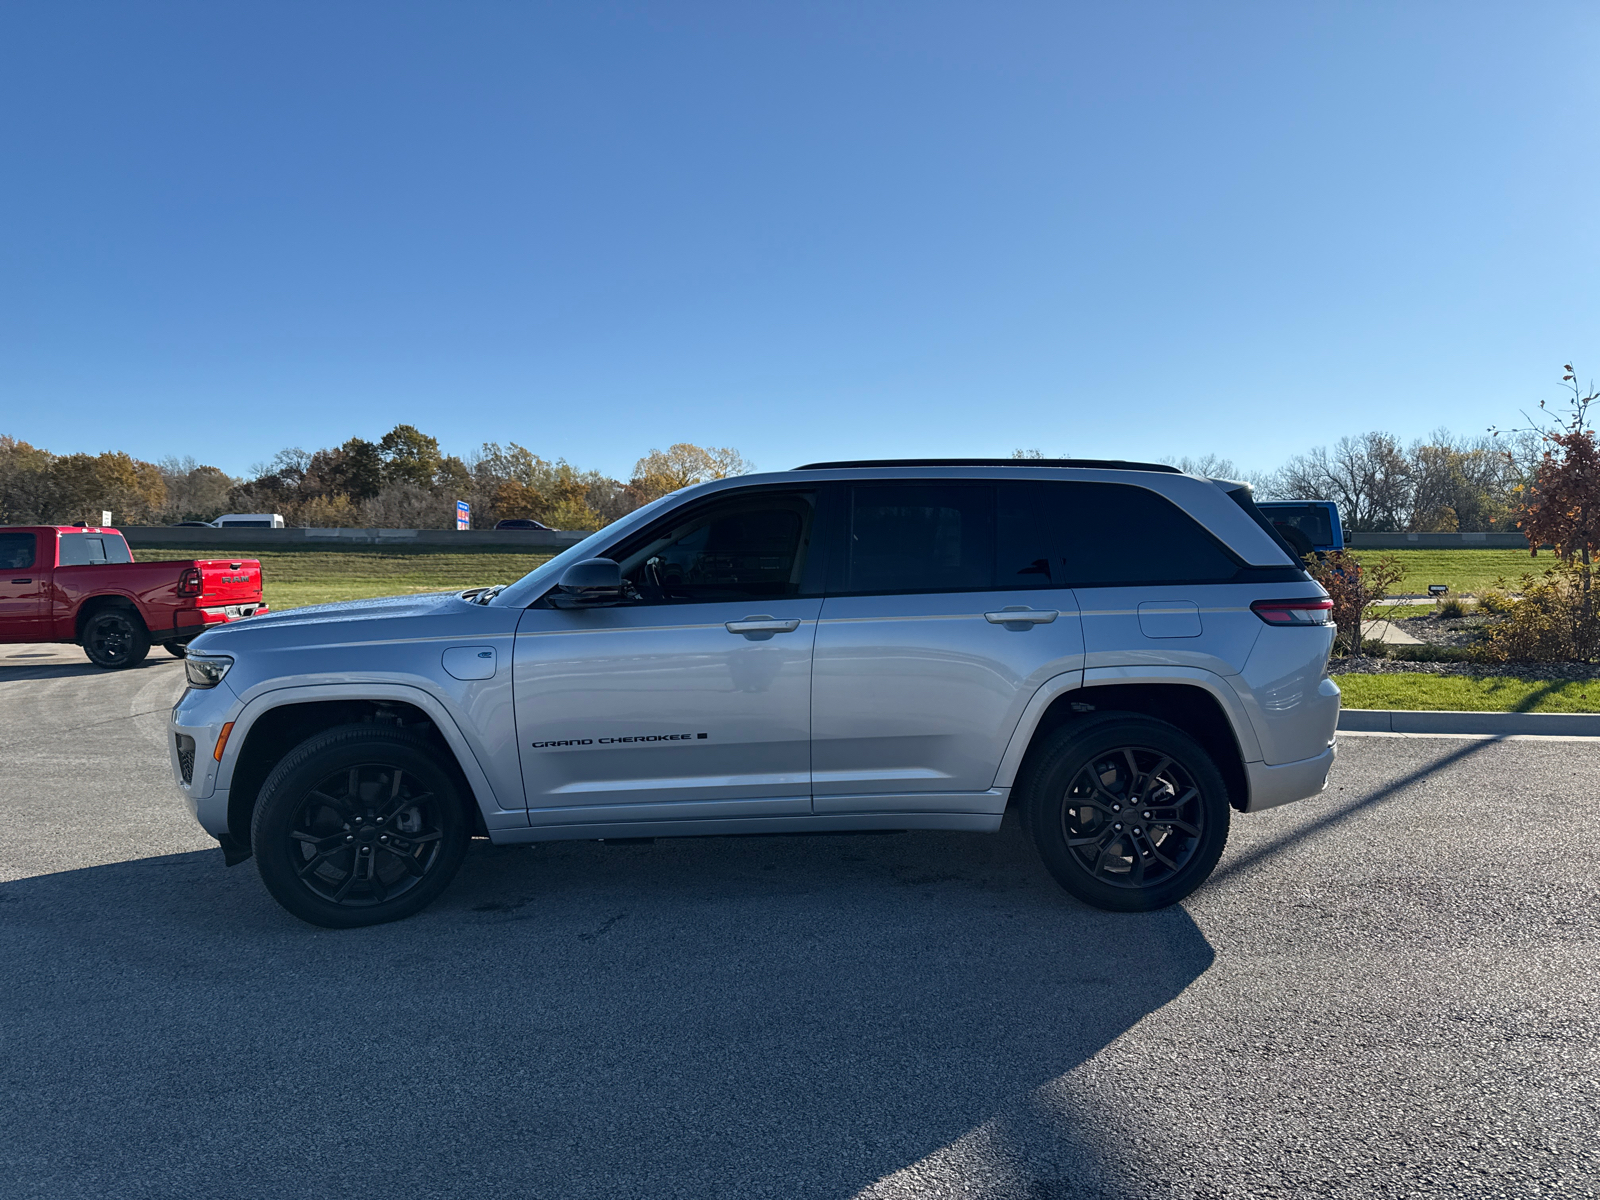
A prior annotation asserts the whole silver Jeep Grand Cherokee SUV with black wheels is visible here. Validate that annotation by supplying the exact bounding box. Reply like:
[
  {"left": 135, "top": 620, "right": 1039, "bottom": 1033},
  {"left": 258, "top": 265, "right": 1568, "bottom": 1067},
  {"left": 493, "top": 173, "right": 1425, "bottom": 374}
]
[{"left": 171, "top": 459, "right": 1339, "bottom": 926}]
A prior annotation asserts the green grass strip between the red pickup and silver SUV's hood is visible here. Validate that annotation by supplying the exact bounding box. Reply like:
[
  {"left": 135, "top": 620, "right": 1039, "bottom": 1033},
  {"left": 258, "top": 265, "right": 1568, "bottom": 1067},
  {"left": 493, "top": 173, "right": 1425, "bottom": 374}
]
[{"left": 133, "top": 546, "right": 550, "bottom": 610}]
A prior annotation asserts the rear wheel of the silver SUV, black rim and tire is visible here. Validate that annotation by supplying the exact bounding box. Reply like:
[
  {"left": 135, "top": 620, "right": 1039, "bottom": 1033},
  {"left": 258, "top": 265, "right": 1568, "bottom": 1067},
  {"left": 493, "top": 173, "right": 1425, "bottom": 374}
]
[{"left": 1021, "top": 712, "right": 1230, "bottom": 912}]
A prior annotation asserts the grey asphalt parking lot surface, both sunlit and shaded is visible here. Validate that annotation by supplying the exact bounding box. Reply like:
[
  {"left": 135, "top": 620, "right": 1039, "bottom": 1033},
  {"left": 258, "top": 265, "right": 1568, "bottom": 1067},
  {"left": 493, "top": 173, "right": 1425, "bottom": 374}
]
[{"left": 0, "top": 646, "right": 1600, "bottom": 1200}]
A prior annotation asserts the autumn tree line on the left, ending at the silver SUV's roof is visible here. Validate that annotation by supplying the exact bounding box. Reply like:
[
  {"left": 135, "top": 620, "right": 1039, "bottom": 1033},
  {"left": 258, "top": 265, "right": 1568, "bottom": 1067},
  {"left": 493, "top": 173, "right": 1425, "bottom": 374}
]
[{"left": 0, "top": 424, "right": 754, "bottom": 530}]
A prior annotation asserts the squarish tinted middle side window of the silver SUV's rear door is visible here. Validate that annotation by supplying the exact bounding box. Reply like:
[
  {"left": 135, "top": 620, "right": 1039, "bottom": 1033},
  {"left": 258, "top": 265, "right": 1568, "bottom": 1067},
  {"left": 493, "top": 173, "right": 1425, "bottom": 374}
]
[{"left": 842, "top": 483, "right": 995, "bottom": 592}]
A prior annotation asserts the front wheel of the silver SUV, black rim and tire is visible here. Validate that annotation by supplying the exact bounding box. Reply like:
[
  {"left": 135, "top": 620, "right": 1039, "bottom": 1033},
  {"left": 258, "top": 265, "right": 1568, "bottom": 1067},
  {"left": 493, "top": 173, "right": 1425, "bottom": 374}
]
[{"left": 250, "top": 725, "right": 472, "bottom": 930}]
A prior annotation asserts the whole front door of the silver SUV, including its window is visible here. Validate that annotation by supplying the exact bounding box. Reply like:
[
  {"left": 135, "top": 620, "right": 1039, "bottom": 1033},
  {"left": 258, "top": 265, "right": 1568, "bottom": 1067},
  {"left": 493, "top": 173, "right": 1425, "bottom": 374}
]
[{"left": 514, "top": 490, "right": 822, "bottom": 826}]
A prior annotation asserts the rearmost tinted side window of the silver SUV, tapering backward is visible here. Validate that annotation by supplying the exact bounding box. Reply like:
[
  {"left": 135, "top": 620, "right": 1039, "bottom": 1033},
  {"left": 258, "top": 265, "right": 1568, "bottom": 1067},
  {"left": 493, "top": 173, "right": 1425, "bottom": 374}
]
[{"left": 1002, "top": 482, "right": 1238, "bottom": 587}]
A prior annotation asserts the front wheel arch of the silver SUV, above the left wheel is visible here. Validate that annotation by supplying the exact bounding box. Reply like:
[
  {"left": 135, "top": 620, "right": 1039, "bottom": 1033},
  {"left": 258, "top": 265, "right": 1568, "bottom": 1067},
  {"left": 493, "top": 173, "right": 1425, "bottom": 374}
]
[{"left": 218, "top": 685, "right": 502, "bottom": 848}]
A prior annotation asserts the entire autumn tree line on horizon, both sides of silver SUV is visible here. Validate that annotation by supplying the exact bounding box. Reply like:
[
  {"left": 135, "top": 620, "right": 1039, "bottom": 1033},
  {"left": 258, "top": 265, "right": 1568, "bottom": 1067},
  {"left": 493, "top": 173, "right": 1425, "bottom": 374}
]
[{"left": 0, "top": 424, "right": 1542, "bottom": 533}]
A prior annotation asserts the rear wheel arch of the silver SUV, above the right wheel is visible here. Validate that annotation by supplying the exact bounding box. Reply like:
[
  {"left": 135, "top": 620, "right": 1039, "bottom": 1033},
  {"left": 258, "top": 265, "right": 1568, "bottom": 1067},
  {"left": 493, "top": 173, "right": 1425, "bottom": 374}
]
[{"left": 995, "top": 669, "right": 1261, "bottom": 811}]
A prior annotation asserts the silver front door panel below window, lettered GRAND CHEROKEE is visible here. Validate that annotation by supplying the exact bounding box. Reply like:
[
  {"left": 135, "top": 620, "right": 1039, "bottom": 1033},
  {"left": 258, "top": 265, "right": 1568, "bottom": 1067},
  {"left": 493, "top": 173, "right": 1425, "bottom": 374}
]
[{"left": 514, "top": 598, "right": 822, "bottom": 824}]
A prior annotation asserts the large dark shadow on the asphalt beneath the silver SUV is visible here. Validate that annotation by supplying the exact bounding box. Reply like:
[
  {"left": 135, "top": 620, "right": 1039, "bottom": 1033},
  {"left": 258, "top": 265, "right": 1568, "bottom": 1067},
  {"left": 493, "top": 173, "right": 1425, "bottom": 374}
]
[{"left": 0, "top": 822, "right": 1213, "bottom": 1200}]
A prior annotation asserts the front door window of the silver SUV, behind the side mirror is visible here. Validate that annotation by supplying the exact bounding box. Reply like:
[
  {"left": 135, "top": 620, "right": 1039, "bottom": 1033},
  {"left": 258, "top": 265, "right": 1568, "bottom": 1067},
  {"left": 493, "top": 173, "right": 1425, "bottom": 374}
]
[{"left": 618, "top": 493, "right": 814, "bottom": 603}]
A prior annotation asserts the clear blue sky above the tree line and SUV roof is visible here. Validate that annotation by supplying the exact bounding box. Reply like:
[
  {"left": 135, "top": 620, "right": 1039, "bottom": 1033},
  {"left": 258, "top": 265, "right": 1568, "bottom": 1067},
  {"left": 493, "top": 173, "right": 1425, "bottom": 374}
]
[{"left": 0, "top": 0, "right": 1600, "bottom": 477}]
